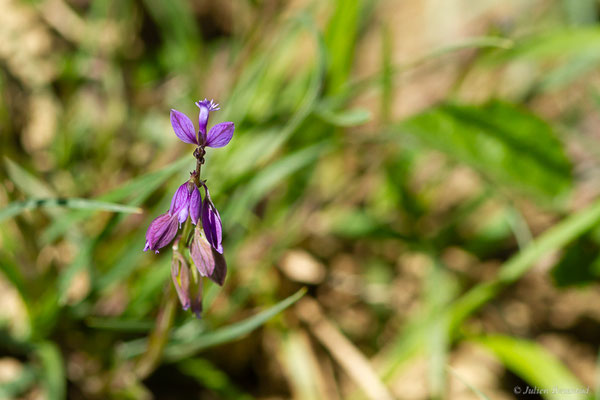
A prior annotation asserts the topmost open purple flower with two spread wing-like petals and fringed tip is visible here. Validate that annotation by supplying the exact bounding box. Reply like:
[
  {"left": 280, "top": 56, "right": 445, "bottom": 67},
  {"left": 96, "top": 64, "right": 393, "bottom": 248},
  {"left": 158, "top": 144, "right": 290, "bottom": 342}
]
[{"left": 171, "top": 99, "right": 235, "bottom": 148}]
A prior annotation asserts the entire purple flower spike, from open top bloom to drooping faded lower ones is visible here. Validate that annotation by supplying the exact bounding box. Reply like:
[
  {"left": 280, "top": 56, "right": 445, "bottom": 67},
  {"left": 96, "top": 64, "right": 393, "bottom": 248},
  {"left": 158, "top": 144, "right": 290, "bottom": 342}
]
[{"left": 144, "top": 99, "right": 234, "bottom": 317}]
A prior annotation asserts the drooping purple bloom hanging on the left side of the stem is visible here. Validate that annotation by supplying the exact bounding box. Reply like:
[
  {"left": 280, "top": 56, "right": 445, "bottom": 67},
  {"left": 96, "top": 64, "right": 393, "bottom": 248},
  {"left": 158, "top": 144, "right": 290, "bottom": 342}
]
[{"left": 144, "top": 182, "right": 202, "bottom": 253}]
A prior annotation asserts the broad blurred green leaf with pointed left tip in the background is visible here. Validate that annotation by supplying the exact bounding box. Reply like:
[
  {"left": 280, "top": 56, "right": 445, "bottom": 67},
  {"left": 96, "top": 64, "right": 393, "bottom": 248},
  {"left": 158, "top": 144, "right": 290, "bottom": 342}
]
[{"left": 399, "top": 101, "right": 572, "bottom": 202}]
